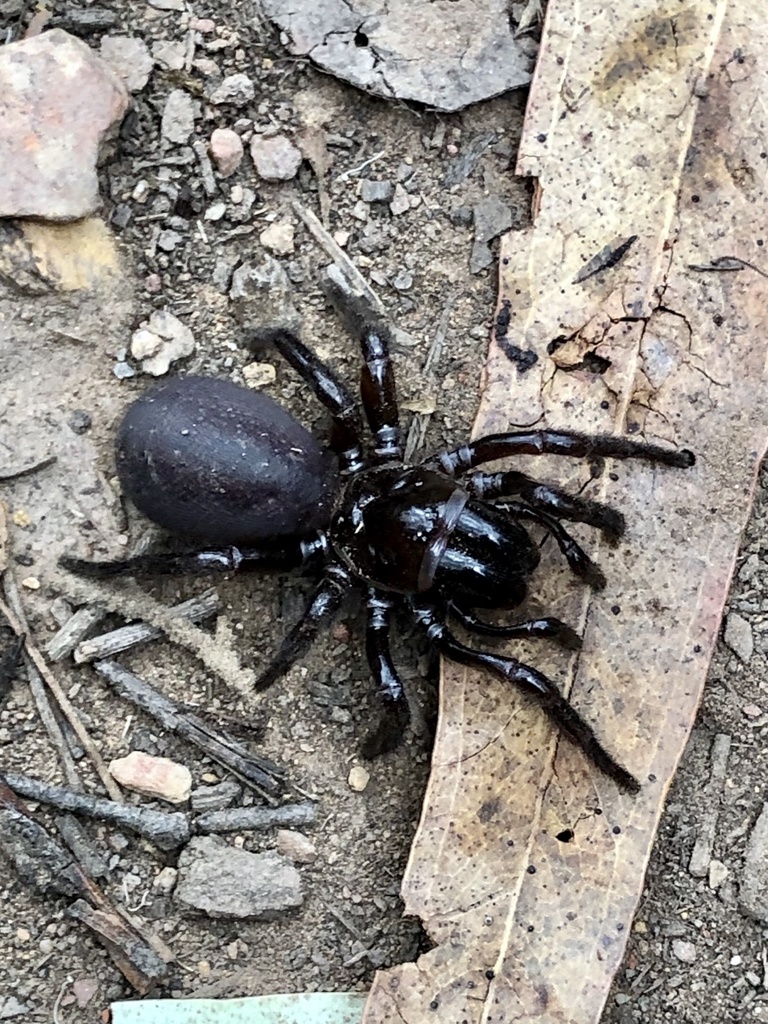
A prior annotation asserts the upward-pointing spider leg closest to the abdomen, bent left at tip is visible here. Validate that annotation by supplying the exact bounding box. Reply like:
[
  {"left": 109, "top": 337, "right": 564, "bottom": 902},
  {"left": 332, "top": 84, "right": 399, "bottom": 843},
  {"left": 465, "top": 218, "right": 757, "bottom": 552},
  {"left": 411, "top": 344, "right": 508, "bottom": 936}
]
[{"left": 249, "top": 328, "right": 364, "bottom": 473}]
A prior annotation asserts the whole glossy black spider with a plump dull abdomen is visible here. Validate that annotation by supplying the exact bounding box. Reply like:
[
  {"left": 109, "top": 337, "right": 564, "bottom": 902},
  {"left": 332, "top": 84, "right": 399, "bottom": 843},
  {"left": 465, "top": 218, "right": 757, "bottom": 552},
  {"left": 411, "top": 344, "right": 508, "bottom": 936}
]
[{"left": 63, "top": 289, "right": 694, "bottom": 792}]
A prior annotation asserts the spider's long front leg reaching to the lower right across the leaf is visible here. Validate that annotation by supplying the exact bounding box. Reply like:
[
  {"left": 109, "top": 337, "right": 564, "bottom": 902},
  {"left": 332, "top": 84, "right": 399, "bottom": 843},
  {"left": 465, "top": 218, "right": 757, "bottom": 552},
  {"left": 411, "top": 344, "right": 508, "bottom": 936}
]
[{"left": 413, "top": 603, "right": 640, "bottom": 793}]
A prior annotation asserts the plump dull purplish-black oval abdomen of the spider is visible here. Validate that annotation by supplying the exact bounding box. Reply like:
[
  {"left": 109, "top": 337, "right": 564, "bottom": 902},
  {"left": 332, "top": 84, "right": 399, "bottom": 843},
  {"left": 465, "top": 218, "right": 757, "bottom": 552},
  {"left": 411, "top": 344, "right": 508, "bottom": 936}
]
[{"left": 117, "top": 377, "right": 337, "bottom": 545}]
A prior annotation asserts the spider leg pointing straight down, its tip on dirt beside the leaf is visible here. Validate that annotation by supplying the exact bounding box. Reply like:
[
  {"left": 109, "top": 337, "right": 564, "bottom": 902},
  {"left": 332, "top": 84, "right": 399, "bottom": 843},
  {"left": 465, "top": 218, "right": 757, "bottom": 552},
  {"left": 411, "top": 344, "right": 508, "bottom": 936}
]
[{"left": 360, "top": 588, "right": 411, "bottom": 758}]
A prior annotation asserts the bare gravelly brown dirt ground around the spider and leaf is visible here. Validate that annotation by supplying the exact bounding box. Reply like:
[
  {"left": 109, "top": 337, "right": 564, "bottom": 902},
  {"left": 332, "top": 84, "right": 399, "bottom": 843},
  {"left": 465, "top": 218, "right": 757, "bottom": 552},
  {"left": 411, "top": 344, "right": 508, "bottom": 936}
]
[{"left": 0, "top": 2, "right": 768, "bottom": 1024}]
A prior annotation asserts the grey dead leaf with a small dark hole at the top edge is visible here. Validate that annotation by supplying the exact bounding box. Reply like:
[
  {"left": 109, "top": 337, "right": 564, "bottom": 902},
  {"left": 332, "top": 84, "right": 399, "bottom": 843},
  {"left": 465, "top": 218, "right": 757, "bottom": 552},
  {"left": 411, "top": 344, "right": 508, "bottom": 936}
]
[{"left": 262, "top": 0, "right": 532, "bottom": 111}]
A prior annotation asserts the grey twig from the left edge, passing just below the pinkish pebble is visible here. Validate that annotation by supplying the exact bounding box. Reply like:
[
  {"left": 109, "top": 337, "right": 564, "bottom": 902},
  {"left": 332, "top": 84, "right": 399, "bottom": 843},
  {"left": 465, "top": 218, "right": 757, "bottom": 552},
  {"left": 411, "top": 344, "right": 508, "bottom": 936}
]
[{"left": 4, "top": 772, "right": 189, "bottom": 850}]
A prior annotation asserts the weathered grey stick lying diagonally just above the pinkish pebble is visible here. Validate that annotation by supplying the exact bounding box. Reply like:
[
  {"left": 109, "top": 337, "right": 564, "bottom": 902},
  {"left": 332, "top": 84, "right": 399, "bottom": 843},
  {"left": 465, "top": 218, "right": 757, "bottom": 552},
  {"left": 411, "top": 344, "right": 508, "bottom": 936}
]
[{"left": 94, "top": 662, "right": 284, "bottom": 803}]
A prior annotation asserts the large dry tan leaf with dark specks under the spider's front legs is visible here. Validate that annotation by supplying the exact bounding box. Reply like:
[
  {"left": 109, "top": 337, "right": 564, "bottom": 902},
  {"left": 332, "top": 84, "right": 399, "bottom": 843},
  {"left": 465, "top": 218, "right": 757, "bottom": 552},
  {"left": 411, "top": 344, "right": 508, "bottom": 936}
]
[{"left": 365, "top": 0, "right": 768, "bottom": 1024}]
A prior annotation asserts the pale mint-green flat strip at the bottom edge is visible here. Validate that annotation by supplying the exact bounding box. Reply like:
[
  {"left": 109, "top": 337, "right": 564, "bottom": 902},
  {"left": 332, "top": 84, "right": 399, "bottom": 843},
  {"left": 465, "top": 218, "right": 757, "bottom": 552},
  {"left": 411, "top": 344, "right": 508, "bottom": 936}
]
[{"left": 112, "top": 992, "right": 366, "bottom": 1024}]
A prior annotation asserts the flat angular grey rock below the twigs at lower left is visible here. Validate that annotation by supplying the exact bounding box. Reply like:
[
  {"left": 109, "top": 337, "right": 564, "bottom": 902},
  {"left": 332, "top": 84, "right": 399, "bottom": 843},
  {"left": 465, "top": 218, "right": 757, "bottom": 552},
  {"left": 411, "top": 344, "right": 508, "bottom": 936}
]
[{"left": 174, "top": 836, "right": 304, "bottom": 921}]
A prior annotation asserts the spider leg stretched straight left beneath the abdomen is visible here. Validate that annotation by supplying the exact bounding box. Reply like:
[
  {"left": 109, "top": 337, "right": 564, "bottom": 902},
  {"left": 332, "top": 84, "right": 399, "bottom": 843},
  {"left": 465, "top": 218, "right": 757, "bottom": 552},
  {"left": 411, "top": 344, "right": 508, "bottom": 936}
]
[{"left": 58, "top": 532, "right": 328, "bottom": 580}]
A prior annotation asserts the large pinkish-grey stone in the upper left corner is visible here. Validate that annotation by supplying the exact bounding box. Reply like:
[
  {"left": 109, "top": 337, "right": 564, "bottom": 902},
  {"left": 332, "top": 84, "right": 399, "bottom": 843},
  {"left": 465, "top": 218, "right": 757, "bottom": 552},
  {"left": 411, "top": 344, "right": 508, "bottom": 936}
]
[{"left": 0, "top": 29, "right": 129, "bottom": 221}]
